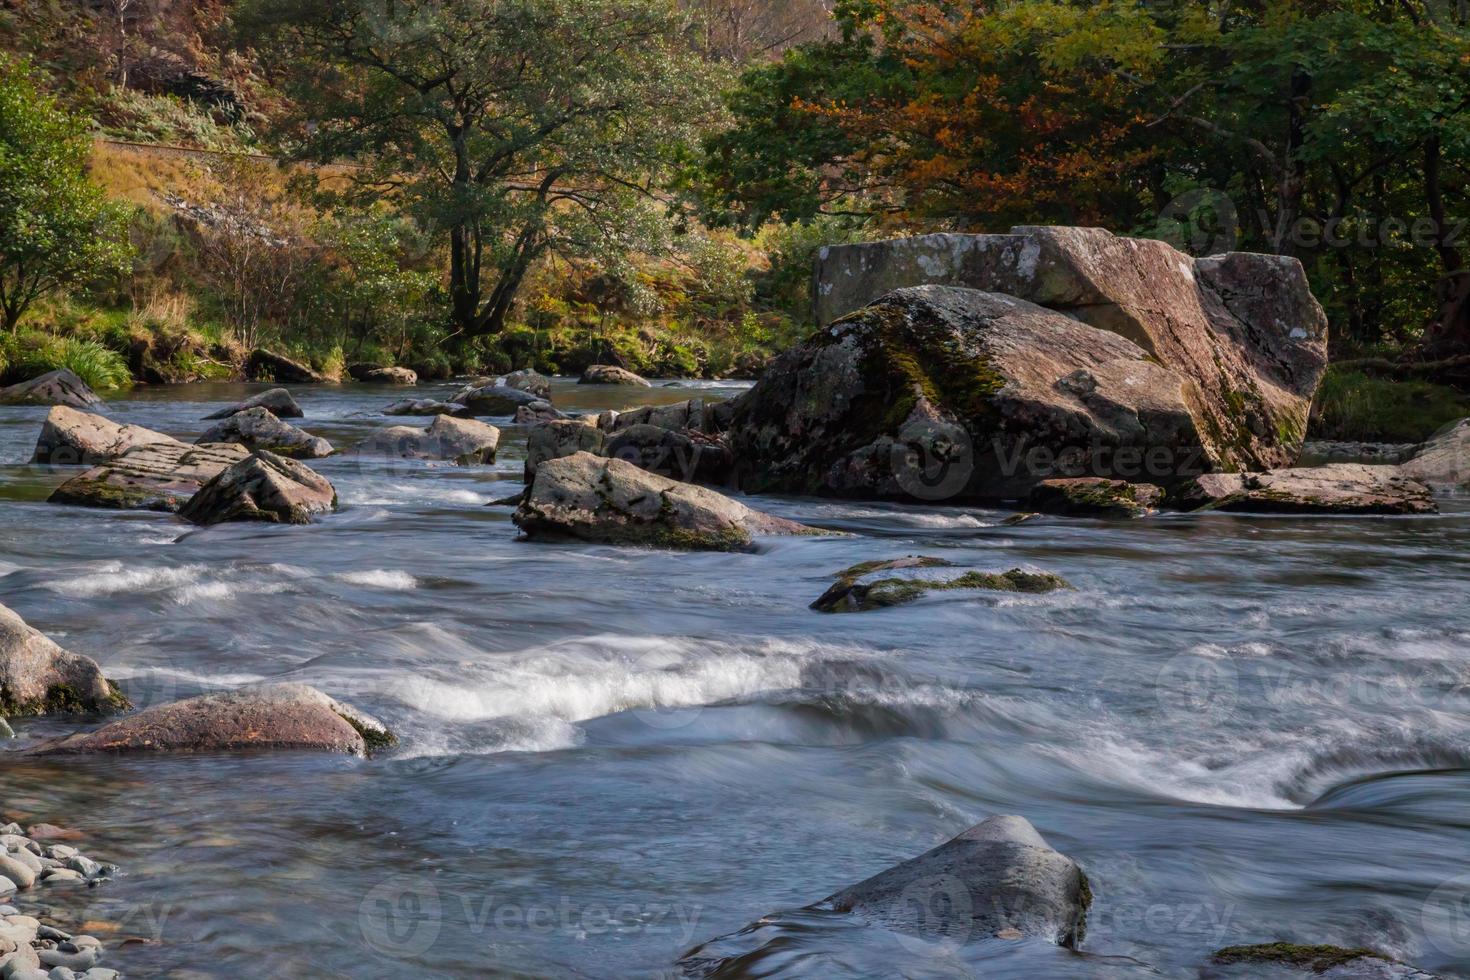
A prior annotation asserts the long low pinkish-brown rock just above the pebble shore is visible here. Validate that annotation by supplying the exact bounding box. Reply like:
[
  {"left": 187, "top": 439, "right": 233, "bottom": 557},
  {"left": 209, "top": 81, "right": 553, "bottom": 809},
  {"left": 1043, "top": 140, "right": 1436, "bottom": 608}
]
[{"left": 31, "top": 683, "right": 397, "bottom": 755}]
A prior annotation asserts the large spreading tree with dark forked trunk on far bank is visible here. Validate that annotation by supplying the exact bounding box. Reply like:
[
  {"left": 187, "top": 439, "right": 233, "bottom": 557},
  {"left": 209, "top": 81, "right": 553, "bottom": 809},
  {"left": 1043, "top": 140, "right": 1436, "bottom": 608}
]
[{"left": 243, "top": 0, "right": 716, "bottom": 336}]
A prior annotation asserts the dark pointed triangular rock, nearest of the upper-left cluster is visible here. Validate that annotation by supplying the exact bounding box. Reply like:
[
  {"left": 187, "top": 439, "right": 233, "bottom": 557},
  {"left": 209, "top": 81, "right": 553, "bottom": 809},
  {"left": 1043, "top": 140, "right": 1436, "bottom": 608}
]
[{"left": 179, "top": 450, "right": 337, "bottom": 527}]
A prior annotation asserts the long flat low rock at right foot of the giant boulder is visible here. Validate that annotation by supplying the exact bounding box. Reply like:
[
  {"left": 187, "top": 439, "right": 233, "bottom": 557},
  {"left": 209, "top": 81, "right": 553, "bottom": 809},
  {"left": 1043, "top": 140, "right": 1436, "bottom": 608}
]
[{"left": 1177, "top": 463, "right": 1439, "bottom": 514}]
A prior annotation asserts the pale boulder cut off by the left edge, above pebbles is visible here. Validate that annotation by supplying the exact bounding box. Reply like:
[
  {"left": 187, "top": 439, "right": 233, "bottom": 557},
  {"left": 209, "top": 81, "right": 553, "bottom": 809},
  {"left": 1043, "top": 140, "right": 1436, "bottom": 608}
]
[{"left": 0, "top": 605, "right": 128, "bottom": 718}]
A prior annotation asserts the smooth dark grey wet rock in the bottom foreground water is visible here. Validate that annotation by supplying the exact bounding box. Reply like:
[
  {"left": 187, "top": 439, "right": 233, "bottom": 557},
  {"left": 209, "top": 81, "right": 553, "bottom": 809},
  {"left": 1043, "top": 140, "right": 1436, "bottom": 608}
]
[{"left": 679, "top": 817, "right": 1092, "bottom": 976}]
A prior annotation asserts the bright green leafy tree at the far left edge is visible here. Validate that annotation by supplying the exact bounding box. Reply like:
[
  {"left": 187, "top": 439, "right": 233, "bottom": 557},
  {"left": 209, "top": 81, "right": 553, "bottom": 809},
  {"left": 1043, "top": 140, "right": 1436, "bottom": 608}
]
[{"left": 0, "top": 56, "right": 131, "bottom": 332}]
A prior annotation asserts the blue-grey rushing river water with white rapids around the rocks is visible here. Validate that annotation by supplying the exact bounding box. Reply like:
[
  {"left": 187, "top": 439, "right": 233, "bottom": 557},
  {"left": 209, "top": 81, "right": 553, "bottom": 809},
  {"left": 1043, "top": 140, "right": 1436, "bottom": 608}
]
[{"left": 0, "top": 381, "right": 1470, "bottom": 977}]
